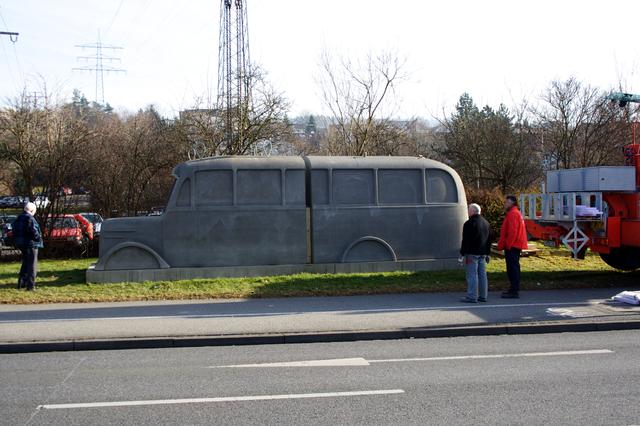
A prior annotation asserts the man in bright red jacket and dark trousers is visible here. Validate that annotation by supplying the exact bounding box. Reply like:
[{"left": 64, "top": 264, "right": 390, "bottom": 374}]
[{"left": 498, "top": 195, "right": 527, "bottom": 299}]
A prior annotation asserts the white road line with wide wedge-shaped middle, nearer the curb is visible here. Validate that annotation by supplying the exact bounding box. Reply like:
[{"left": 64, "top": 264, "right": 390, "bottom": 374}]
[{"left": 208, "top": 349, "right": 613, "bottom": 368}]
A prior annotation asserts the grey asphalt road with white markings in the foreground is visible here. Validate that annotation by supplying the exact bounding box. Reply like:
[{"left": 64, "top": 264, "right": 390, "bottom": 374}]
[{"left": 0, "top": 331, "right": 640, "bottom": 426}]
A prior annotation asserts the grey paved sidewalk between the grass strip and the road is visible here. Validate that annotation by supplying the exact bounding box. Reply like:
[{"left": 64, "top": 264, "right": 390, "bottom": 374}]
[{"left": 0, "top": 289, "right": 640, "bottom": 353}]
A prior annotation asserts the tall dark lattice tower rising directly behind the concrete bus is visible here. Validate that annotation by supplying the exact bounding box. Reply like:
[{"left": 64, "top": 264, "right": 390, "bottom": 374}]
[{"left": 216, "top": 0, "right": 251, "bottom": 151}]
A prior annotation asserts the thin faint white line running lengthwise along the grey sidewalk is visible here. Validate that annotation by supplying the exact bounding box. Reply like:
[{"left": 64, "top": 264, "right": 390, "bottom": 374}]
[{"left": 0, "top": 301, "right": 601, "bottom": 324}]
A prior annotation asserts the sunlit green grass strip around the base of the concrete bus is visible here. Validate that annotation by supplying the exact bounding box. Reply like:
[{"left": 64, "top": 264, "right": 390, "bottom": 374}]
[{"left": 0, "top": 250, "right": 640, "bottom": 304}]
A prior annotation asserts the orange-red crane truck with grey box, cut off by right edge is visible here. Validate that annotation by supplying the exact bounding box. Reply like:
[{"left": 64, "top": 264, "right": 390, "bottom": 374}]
[{"left": 520, "top": 94, "right": 640, "bottom": 271}]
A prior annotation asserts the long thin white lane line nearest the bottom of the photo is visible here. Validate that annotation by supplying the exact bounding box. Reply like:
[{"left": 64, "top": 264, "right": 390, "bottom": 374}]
[{"left": 38, "top": 389, "right": 404, "bottom": 410}]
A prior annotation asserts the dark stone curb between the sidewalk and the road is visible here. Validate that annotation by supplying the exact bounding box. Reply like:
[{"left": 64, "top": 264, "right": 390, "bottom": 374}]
[{"left": 0, "top": 320, "right": 640, "bottom": 354}]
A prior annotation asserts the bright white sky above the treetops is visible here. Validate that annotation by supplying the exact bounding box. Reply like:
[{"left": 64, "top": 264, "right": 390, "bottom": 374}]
[{"left": 0, "top": 0, "right": 640, "bottom": 118}]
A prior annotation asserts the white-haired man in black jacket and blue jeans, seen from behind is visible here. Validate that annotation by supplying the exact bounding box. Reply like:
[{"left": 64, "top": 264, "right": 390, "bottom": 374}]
[{"left": 460, "top": 203, "right": 491, "bottom": 303}]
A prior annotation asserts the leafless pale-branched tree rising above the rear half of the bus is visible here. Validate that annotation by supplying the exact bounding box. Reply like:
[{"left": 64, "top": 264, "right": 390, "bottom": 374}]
[{"left": 318, "top": 51, "right": 406, "bottom": 155}]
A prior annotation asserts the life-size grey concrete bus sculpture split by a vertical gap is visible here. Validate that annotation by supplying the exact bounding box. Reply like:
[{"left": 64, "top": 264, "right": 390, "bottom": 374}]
[{"left": 87, "top": 156, "right": 467, "bottom": 282}]
